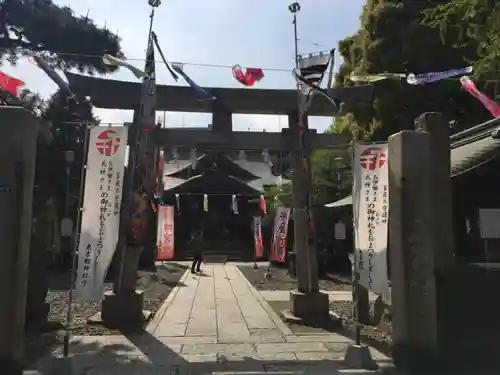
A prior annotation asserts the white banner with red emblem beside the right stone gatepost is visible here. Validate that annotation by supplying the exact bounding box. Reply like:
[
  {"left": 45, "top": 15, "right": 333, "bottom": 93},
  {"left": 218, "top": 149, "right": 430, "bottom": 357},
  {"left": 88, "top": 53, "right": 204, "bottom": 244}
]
[{"left": 352, "top": 144, "right": 389, "bottom": 296}]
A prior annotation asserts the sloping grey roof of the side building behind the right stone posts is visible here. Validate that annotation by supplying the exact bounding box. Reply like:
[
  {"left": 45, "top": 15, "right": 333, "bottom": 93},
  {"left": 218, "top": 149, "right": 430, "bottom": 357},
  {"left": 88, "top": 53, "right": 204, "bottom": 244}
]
[{"left": 325, "top": 118, "right": 500, "bottom": 207}]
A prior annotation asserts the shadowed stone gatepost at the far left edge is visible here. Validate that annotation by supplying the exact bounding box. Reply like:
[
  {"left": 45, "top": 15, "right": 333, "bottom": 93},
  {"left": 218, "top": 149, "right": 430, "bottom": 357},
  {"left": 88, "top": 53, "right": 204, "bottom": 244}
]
[{"left": 0, "top": 107, "right": 39, "bottom": 375}]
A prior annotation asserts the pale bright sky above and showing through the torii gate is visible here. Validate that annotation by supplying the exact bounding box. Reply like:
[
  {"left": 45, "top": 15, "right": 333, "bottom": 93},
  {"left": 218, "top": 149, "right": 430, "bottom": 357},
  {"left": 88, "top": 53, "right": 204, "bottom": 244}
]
[{"left": 2, "top": 0, "right": 365, "bottom": 131}]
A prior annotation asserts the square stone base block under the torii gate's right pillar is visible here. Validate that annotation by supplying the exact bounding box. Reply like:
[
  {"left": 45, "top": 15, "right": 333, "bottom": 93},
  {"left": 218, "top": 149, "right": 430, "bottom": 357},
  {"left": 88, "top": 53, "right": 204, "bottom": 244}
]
[{"left": 290, "top": 290, "right": 330, "bottom": 319}]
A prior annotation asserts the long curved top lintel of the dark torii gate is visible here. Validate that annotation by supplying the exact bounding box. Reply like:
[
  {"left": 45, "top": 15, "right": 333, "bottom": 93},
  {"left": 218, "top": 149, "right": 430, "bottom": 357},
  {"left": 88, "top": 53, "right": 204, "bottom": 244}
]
[{"left": 66, "top": 73, "right": 373, "bottom": 116}]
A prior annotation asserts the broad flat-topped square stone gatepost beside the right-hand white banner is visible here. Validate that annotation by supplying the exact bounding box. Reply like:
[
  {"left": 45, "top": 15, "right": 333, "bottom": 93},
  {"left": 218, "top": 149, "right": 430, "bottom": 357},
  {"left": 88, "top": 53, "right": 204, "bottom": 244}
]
[{"left": 389, "top": 131, "right": 438, "bottom": 367}]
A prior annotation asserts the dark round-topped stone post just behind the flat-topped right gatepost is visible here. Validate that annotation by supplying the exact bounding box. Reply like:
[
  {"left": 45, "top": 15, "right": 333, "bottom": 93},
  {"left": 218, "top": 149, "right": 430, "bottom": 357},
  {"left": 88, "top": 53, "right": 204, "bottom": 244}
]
[{"left": 415, "top": 112, "right": 455, "bottom": 271}]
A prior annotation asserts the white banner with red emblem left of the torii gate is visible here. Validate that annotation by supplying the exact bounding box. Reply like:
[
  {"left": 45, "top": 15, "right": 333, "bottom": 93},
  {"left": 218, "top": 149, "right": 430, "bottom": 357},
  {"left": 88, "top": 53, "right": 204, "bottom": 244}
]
[{"left": 76, "top": 126, "right": 128, "bottom": 301}]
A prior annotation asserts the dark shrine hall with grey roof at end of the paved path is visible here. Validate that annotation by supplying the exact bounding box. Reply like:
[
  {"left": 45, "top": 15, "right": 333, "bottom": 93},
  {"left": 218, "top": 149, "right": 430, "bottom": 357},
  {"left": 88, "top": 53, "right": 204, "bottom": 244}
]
[{"left": 163, "top": 149, "right": 277, "bottom": 259}]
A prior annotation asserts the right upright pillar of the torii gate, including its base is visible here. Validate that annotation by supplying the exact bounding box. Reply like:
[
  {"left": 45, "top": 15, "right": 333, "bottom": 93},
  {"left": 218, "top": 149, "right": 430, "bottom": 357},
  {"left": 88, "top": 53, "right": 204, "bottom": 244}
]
[{"left": 286, "top": 112, "right": 329, "bottom": 318}]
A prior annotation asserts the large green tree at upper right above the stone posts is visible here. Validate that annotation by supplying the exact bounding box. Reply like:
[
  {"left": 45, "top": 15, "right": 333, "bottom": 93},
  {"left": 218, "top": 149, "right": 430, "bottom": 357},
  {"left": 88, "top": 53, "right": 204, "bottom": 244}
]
[{"left": 336, "top": 0, "right": 500, "bottom": 140}]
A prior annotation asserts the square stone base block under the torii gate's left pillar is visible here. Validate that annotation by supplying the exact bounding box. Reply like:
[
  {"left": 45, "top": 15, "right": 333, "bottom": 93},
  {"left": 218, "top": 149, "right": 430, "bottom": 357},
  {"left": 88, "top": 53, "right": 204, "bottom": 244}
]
[{"left": 96, "top": 291, "right": 151, "bottom": 328}]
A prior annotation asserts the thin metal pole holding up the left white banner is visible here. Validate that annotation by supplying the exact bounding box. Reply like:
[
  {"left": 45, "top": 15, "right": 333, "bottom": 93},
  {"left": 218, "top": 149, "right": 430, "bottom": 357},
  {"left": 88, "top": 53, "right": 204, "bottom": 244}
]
[{"left": 63, "top": 121, "right": 91, "bottom": 357}]
